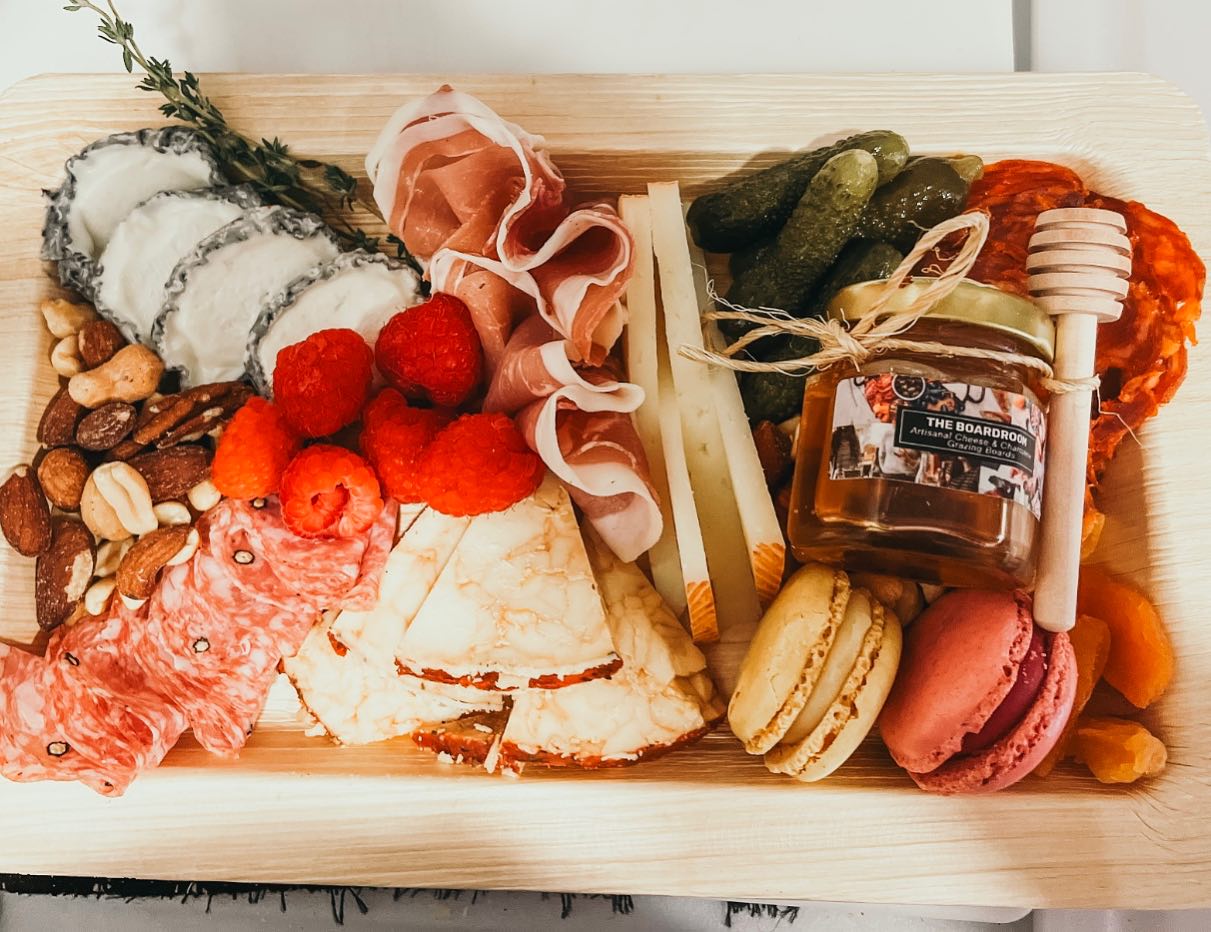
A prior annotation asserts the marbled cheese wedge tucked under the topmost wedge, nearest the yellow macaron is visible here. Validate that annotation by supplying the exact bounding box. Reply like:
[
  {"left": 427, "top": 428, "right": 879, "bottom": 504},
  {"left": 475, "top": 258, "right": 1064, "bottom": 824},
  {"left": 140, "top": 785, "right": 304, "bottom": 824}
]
[{"left": 500, "top": 529, "right": 723, "bottom": 769}]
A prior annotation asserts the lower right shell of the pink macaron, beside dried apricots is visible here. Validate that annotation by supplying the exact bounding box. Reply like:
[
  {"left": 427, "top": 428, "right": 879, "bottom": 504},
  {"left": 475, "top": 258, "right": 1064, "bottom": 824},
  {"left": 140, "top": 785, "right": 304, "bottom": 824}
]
[{"left": 909, "top": 634, "right": 1077, "bottom": 795}]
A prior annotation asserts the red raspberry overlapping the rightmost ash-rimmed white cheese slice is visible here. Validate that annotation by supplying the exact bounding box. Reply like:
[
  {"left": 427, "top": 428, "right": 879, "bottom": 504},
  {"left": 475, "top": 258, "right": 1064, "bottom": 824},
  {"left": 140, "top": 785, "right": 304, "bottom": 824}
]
[{"left": 274, "top": 328, "right": 374, "bottom": 437}]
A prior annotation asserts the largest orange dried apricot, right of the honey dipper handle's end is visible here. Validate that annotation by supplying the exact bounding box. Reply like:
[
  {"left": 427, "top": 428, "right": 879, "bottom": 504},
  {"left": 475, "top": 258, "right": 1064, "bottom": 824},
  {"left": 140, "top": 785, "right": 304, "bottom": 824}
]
[{"left": 1077, "top": 566, "right": 1173, "bottom": 708}]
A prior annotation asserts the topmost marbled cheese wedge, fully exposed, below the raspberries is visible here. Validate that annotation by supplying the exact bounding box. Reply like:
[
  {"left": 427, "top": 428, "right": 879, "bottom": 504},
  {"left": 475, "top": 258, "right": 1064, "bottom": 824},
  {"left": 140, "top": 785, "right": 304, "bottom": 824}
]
[{"left": 396, "top": 474, "right": 621, "bottom": 690}]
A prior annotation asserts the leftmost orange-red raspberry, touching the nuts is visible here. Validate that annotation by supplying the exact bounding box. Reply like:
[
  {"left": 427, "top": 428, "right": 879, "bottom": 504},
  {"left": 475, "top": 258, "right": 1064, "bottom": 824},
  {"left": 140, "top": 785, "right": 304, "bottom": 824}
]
[{"left": 211, "top": 397, "right": 303, "bottom": 499}]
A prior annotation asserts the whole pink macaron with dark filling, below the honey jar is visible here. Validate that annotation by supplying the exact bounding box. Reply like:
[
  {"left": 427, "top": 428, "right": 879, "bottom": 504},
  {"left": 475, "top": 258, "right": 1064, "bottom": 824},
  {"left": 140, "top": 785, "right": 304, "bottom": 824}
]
[{"left": 879, "top": 589, "right": 1077, "bottom": 794}]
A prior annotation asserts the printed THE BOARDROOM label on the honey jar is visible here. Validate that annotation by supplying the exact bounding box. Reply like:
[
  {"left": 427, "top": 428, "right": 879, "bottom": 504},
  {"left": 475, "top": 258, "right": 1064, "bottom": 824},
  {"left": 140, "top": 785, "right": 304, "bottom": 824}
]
[{"left": 828, "top": 372, "right": 1046, "bottom": 518}]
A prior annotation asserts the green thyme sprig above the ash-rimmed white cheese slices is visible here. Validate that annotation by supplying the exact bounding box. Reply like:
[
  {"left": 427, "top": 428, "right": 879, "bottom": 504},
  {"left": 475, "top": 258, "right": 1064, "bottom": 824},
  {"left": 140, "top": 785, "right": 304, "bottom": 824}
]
[{"left": 63, "top": 0, "right": 415, "bottom": 265}]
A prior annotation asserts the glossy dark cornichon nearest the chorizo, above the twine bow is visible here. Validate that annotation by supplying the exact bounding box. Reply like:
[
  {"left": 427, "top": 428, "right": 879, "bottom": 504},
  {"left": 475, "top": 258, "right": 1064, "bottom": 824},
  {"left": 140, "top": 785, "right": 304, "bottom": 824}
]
[{"left": 857, "top": 155, "right": 983, "bottom": 252}]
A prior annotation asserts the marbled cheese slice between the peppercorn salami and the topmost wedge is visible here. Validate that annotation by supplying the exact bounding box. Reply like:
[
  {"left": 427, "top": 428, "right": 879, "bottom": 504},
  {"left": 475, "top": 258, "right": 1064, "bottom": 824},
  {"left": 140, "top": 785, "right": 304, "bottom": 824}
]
[{"left": 332, "top": 506, "right": 471, "bottom": 667}]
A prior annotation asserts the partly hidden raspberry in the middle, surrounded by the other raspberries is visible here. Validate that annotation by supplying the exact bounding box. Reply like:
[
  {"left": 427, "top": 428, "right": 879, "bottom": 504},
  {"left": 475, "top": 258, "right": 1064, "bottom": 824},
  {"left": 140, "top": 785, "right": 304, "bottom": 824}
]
[{"left": 362, "top": 389, "right": 446, "bottom": 502}]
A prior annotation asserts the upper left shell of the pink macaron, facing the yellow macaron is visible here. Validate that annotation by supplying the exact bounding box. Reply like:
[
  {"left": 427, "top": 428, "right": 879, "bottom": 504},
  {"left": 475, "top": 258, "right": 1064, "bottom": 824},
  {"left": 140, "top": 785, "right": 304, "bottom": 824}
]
[{"left": 879, "top": 589, "right": 1034, "bottom": 773}]
